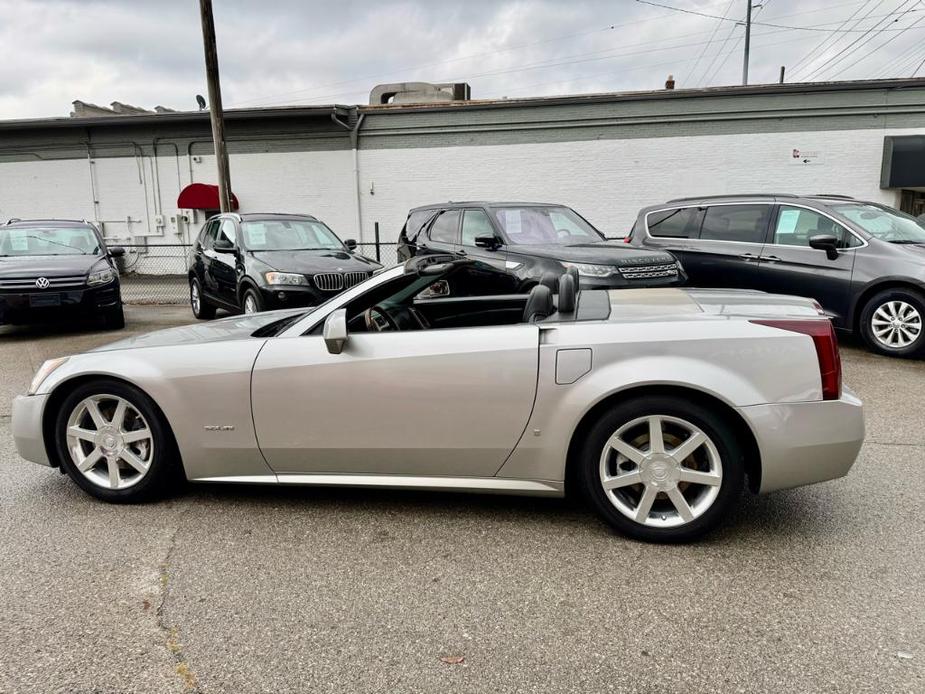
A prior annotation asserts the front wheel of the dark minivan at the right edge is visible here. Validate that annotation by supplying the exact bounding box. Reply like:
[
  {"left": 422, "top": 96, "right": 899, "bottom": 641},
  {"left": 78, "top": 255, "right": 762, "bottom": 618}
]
[{"left": 861, "top": 287, "right": 925, "bottom": 357}]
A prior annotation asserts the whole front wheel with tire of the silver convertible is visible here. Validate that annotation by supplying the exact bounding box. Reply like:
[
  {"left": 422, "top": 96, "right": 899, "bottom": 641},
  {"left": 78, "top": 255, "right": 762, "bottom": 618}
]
[{"left": 54, "top": 379, "right": 179, "bottom": 502}]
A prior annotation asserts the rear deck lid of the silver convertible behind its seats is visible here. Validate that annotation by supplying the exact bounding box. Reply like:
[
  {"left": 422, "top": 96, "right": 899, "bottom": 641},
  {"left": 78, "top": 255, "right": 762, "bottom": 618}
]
[{"left": 608, "top": 288, "right": 824, "bottom": 320}]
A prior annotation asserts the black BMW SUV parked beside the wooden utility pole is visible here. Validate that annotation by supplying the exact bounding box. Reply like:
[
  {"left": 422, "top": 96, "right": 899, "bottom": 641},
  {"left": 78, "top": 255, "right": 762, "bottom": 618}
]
[{"left": 189, "top": 213, "right": 382, "bottom": 319}]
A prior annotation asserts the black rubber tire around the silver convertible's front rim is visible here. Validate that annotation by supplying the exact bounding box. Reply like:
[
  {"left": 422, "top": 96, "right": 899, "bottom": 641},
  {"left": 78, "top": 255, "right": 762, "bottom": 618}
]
[{"left": 54, "top": 379, "right": 184, "bottom": 503}]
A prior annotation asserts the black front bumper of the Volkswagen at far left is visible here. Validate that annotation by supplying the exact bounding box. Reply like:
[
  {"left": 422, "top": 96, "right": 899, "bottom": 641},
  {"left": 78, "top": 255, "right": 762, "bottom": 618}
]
[{"left": 0, "top": 282, "right": 122, "bottom": 323}]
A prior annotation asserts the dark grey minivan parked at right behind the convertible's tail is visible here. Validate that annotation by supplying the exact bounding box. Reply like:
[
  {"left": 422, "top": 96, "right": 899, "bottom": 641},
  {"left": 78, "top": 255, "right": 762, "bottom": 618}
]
[{"left": 630, "top": 195, "right": 925, "bottom": 357}]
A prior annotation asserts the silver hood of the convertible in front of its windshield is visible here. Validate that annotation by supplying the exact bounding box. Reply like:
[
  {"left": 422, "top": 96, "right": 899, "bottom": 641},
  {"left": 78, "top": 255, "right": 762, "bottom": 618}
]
[{"left": 89, "top": 308, "right": 311, "bottom": 352}]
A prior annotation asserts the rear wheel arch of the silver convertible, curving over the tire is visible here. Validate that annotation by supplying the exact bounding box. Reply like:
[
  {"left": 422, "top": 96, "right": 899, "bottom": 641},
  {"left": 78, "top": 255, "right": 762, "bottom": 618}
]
[{"left": 565, "top": 385, "right": 761, "bottom": 494}]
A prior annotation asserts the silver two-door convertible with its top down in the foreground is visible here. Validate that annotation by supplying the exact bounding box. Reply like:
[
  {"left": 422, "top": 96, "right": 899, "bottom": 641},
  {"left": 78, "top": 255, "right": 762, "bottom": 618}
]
[{"left": 12, "top": 256, "right": 864, "bottom": 541}]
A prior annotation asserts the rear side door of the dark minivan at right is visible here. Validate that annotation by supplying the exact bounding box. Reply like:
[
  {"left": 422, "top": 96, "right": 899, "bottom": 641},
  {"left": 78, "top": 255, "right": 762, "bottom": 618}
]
[{"left": 666, "top": 203, "right": 772, "bottom": 289}]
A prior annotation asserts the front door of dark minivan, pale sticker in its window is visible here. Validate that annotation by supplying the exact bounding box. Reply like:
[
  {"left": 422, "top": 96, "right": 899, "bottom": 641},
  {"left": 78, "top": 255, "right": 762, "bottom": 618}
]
[{"left": 759, "top": 205, "right": 862, "bottom": 325}]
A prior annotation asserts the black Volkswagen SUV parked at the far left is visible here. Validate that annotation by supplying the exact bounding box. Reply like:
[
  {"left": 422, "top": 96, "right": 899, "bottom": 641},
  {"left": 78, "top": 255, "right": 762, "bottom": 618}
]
[{"left": 0, "top": 219, "right": 125, "bottom": 329}]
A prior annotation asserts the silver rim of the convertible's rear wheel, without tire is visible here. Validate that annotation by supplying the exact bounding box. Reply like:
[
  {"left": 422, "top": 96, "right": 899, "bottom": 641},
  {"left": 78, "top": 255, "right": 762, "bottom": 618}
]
[{"left": 600, "top": 415, "right": 723, "bottom": 528}]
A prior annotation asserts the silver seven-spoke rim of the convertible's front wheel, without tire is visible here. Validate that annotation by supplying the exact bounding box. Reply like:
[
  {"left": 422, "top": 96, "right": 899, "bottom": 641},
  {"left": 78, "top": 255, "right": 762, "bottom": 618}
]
[{"left": 66, "top": 395, "right": 154, "bottom": 489}]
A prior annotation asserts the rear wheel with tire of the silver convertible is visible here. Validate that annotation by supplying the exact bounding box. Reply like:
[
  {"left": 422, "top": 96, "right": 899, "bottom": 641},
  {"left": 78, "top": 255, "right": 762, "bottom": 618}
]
[{"left": 578, "top": 396, "right": 744, "bottom": 542}]
